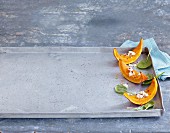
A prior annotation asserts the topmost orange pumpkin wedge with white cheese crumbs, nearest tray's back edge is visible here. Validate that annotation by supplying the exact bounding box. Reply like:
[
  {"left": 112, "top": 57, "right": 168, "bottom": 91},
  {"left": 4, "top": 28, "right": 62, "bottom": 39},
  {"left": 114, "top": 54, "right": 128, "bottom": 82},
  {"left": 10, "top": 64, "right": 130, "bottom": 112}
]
[{"left": 113, "top": 39, "right": 143, "bottom": 64}]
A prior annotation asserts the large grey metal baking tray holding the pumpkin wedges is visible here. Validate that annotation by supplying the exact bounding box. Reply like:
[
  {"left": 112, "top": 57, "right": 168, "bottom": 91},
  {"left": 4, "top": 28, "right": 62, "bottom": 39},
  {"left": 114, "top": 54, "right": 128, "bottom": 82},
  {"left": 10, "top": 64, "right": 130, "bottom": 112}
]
[{"left": 0, "top": 47, "right": 164, "bottom": 118}]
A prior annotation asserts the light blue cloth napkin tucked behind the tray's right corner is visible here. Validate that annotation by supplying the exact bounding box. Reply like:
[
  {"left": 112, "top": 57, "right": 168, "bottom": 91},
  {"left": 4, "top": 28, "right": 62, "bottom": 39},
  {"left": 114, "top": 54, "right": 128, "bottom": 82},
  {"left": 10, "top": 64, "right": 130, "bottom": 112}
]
[{"left": 120, "top": 38, "right": 170, "bottom": 80}]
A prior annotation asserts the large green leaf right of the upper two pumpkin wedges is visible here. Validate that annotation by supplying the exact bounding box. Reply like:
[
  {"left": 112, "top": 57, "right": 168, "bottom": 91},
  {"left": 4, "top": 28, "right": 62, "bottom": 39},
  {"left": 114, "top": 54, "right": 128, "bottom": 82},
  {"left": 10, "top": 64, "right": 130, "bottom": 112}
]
[{"left": 137, "top": 57, "right": 152, "bottom": 69}]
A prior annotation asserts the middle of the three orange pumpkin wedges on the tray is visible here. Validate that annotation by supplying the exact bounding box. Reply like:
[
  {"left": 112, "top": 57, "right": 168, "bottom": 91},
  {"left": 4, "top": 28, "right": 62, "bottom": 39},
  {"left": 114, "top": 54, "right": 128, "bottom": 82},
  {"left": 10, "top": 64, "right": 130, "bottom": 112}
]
[{"left": 119, "top": 59, "right": 148, "bottom": 84}]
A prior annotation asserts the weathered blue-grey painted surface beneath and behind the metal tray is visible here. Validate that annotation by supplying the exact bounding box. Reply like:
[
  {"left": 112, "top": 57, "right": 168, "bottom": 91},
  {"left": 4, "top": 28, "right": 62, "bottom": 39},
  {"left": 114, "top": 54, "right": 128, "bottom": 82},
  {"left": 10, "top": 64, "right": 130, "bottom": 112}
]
[{"left": 0, "top": 0, "right": 170, "bottom": 133}]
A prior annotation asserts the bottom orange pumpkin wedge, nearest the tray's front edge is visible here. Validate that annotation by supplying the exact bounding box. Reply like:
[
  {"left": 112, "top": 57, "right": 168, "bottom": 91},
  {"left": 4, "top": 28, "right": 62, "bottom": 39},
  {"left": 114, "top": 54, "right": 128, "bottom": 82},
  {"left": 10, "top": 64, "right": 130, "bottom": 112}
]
[{"left": 123, "top": 77, "right": 158, "bottom": 105}]
